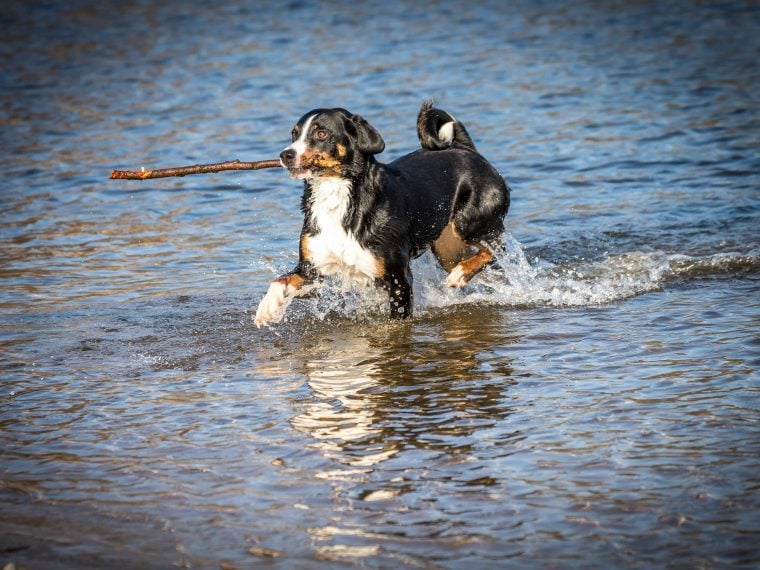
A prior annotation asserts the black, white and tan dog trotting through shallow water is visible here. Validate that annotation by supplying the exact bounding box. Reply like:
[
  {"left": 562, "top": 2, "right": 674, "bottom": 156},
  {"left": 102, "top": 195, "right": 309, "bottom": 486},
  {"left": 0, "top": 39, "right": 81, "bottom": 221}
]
[{"left": 254, "top": 101, "right": 510, "bottom": 327}]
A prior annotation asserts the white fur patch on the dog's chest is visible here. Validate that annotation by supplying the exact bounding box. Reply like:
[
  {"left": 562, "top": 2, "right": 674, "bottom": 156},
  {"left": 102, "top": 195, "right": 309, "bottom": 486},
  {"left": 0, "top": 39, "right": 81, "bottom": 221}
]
[{"left": 308, "top": 179, "right": 380, "bottom": 285}]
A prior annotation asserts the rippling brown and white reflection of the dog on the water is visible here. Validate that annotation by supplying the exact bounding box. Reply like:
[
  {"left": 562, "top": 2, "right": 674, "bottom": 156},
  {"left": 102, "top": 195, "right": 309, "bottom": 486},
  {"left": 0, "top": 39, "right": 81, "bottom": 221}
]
[{"left": 284, "top": 310, "right": 516, "bottom": 468}]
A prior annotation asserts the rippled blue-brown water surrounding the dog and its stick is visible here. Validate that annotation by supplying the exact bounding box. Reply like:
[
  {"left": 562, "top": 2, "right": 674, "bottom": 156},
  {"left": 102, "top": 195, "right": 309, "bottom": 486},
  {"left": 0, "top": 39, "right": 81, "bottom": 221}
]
[{"left": 0, "top": 2, "right": 760, "bottom": 569}]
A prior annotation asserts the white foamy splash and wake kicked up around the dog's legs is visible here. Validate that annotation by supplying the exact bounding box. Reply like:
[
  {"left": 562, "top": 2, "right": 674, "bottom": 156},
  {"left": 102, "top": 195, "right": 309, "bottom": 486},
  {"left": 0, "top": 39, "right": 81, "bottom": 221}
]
[{"left": 282, "top": 234, "right": 760, "bottom": 320}]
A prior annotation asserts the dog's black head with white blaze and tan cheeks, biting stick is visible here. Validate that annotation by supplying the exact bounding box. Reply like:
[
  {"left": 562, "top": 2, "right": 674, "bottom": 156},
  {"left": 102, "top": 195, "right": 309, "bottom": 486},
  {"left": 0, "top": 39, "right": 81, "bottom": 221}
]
[{"left": 280, "top": 109, "right": 385, "bottom": 180}]
